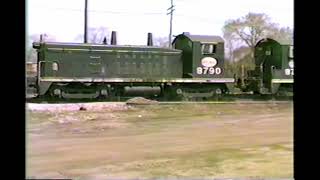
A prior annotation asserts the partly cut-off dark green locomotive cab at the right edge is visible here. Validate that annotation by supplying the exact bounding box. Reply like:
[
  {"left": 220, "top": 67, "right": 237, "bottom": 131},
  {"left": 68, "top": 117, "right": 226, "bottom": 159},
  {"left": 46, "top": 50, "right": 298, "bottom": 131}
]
[{"left": 250, "top": 38, "right": 294, "bottom": 94}]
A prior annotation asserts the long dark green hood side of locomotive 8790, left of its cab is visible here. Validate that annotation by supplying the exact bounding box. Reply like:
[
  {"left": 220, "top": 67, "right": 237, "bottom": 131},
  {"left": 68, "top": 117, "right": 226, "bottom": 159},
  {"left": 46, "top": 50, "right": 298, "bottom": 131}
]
[{"left": 37, "top": 45, "right": 182, "bottom": 79}]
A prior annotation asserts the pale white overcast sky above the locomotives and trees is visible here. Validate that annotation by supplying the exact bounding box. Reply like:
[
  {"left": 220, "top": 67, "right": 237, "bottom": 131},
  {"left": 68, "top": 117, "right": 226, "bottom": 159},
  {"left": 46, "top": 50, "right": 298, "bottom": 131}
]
[{"left": 26, "top": 0, "right": 294, "bottom": 45}]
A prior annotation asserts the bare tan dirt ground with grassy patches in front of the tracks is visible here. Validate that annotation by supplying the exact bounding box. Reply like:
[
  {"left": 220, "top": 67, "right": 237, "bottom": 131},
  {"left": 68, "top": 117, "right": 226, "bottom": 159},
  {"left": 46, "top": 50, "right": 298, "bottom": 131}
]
[{"left": 26, "top": 102, "right": 293, "bottom": 179}]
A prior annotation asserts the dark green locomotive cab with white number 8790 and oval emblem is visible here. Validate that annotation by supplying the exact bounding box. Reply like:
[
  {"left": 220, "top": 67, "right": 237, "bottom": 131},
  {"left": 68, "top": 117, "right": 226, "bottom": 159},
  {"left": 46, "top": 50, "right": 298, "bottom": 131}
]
[{"left": 173, "top": 33, "right": 224, "bottom": 78}]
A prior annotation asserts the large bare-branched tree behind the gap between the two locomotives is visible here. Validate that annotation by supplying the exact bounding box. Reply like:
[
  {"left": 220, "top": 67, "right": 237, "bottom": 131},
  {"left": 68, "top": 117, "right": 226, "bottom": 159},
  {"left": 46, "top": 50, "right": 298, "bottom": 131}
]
[{"left": 223, "top": 13, "right": 293, "bottom": 77}]
